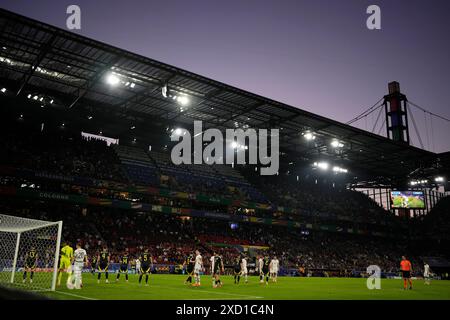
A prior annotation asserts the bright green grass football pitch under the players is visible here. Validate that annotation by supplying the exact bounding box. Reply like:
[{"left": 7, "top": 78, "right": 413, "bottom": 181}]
[{"left": 38, "top": 274, "right": 450, "bottom": 300}]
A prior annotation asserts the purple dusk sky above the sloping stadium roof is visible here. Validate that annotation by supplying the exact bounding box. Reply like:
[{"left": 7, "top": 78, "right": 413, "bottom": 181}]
[{"left": 0, "top": 0, "right": 450, "bottom": 152}]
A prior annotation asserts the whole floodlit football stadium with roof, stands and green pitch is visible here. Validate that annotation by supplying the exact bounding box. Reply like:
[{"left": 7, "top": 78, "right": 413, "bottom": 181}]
[{"left": 0, "top": 5, "right": 450, "bottom": 300}]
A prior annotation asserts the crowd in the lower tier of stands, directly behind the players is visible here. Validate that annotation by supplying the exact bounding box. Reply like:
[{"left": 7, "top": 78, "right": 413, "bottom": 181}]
[{"left": 0, "top": 201, "right": 442, "bottom": 276}]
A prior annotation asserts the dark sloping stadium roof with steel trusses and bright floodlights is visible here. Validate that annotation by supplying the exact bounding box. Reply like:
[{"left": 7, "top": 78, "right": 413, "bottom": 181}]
[{"left": 0, "top": 9, "right": 436, "bottom": 186}]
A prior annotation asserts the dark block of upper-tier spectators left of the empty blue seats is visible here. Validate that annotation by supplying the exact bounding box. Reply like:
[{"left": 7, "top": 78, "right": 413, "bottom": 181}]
[{"left": 0, "top": 131, "right": 125, "bottom": 181}]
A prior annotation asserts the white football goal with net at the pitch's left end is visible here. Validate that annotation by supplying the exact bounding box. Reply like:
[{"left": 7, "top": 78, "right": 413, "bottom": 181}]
[{"left": 0, "top": 214, "right": 62, "bottom": 291}]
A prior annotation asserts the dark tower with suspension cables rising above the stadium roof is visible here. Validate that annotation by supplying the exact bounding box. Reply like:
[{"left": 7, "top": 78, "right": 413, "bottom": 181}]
[{"left": 384, "top": 81, "right": 409, "bottom": 144}]
